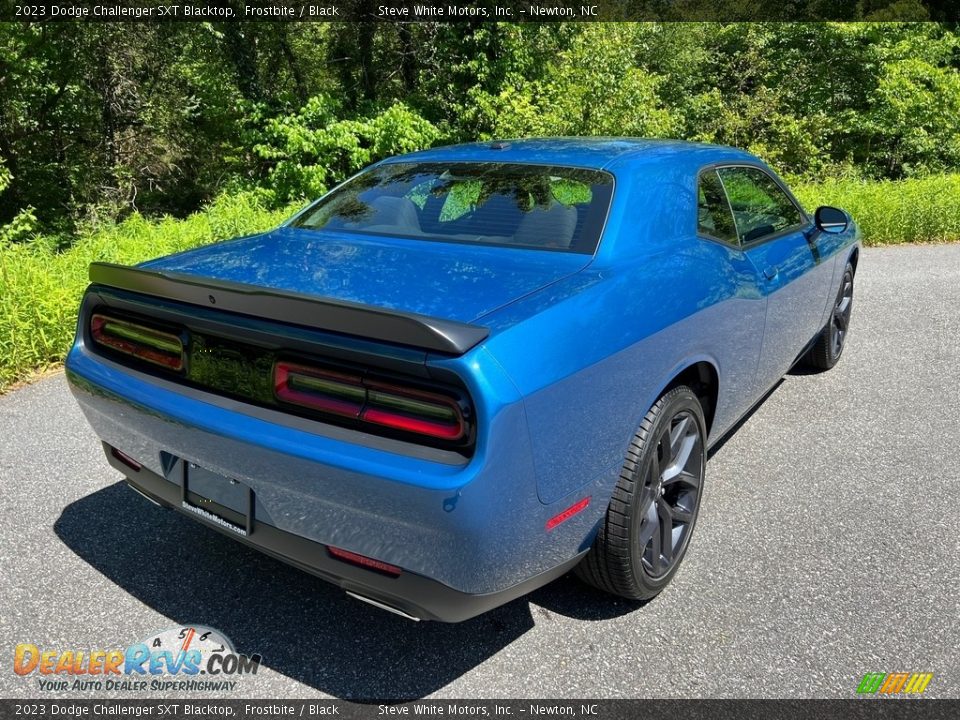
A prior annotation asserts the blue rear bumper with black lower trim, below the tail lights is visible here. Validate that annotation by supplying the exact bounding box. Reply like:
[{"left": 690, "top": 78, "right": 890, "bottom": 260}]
[{"left": 67, "top": 341, "right": 609, "bottom": 621}]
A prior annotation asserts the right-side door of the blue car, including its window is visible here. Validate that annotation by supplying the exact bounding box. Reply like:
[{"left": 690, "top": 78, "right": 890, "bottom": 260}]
[{"left": 716, "top": 165, "right": 832, "bottom": 390}]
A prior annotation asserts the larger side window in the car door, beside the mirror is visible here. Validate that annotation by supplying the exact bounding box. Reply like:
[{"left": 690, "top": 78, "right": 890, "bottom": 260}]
[{"left": 717, "top": 167, "right": 803, "bottom": 243}]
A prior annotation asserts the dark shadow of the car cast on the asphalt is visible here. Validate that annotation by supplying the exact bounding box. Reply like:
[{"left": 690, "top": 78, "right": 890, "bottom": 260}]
[{"left": 54, "top": 482, "right": 636, "bottom": 700}]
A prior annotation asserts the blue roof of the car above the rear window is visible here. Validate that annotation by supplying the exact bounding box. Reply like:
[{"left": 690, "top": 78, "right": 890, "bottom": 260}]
[{"left": 384, "top": 137, "right": 758, "bottom": 170}]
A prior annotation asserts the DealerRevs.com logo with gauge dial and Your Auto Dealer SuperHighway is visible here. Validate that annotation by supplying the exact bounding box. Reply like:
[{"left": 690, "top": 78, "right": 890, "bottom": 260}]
[{"left": 13, "top": 626, "right": 261, "bottom": 692}]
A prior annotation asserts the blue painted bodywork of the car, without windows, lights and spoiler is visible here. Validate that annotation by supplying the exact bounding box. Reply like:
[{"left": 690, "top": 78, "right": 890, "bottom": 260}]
[{"left": 67, "top": 138, "right": 859, "bottom": 612}]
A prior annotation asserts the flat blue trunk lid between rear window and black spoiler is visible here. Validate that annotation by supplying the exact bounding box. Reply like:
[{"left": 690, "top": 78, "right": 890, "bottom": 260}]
[{"left": 140, "top": 227, "right": 591, "bottom": 323}]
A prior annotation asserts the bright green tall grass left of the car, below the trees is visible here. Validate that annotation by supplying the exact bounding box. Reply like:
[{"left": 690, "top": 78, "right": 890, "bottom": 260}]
[{"left": 0, "top": 194, "right": 293, "bottom": 392}]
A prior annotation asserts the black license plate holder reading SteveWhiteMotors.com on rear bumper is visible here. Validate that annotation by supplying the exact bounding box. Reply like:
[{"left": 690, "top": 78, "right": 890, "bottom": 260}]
[{"left": 181, "top": 461, "right": 254, "bottom": 537}]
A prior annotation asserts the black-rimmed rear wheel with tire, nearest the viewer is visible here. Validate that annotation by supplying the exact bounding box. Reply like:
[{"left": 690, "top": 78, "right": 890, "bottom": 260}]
[{"left": 576, "top": 385, "right": 707, "bottom": 600}]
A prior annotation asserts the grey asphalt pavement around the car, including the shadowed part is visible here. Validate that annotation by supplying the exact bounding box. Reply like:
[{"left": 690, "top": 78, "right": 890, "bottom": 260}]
[{"left": 0, "top": 245, "right": 960, "bottom": 698}]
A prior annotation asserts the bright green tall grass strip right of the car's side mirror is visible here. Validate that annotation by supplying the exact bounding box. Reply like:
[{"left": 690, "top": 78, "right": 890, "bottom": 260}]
[{"left": 793, "top": 174, "right": 960, "bottom": 245}]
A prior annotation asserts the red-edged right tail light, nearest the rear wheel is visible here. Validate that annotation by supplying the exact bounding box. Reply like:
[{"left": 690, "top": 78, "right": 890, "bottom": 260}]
[{"left": 274, "top": 362, "right": 467, "bottom": 442}]
